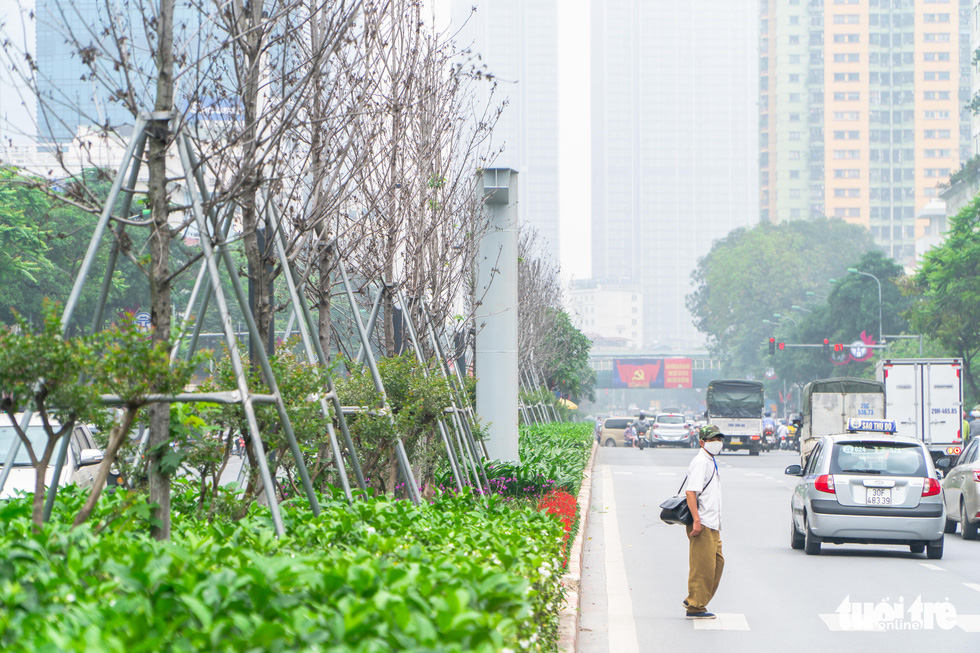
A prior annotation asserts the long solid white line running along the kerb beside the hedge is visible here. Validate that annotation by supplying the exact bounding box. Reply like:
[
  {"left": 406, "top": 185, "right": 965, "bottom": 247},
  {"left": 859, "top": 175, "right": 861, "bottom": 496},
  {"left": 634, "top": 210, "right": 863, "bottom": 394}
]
[{"left": 602, "top": 465, "right": 640, "bottom": 653}]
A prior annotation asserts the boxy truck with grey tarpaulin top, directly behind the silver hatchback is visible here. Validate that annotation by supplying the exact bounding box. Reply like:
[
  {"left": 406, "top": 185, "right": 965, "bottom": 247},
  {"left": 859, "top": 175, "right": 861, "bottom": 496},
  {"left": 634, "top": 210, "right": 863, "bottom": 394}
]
[{"left": 797, "top": 377, "right": 886, "bottom": 466}]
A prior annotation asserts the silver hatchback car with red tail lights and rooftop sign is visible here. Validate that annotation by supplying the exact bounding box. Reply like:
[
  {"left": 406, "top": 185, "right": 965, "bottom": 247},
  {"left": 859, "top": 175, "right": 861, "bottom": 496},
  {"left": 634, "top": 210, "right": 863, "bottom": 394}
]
[{"left": 786, "top": 433, "right": 946, "bottom": 560}]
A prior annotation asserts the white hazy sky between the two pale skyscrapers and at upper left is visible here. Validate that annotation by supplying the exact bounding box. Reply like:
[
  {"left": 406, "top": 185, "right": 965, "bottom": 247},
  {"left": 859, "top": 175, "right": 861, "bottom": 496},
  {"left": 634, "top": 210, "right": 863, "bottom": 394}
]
[{"left": 0, "top": 0, "right": 591, "bottom": 280}]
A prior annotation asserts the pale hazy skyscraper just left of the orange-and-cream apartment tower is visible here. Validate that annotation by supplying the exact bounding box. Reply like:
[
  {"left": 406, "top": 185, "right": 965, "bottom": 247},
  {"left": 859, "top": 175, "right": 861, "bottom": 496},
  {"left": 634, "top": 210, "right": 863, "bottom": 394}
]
[{"left": 591, "top": 0, "right": 759, "bottom": 346}]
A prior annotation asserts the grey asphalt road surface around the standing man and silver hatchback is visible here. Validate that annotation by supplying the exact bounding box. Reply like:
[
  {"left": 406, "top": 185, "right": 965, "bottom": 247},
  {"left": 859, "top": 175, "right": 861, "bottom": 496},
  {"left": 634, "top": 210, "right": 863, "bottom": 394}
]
[{"left": 579, "top": 448, "right": 980, "bottom": 653}]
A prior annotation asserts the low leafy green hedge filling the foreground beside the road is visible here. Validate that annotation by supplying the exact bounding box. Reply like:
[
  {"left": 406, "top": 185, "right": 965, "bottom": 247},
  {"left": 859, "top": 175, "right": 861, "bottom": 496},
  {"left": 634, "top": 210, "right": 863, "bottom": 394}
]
[{"left": 0, "top": 490, "right": 562, "bottom": 653}]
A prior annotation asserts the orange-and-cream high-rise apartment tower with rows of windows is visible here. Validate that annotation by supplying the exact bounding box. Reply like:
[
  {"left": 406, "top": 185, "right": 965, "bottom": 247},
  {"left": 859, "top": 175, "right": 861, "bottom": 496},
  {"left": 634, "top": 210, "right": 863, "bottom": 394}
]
[{"left": 759, "top": 0, "right": 972, "bottom": 265}]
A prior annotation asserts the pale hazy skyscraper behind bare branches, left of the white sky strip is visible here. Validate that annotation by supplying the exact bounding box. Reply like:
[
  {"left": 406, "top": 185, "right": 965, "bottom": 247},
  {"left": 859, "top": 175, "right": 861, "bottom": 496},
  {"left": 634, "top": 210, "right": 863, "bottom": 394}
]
[{"left": 452, "top": 0, "right": 560, "bottom": 263}]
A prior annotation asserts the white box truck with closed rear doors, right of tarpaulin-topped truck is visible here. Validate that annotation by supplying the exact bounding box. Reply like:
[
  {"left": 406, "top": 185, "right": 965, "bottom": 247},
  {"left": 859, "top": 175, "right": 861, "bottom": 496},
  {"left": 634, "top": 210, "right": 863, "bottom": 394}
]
[{"left": 875, "top": 358, "right": 963, "bottom": 460}]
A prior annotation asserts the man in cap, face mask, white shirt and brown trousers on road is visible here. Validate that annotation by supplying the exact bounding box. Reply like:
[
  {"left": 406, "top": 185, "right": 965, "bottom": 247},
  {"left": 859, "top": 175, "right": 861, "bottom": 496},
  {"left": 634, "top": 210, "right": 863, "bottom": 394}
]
[{"left": 684, "top": 425, "right": 725, "bottom": 619}]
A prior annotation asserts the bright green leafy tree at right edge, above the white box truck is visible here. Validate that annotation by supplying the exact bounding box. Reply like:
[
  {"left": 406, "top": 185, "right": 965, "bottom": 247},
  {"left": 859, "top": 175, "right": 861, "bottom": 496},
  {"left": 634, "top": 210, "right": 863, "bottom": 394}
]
[{"left": 907, "top": 197, "right": 980, "bottom": 400}]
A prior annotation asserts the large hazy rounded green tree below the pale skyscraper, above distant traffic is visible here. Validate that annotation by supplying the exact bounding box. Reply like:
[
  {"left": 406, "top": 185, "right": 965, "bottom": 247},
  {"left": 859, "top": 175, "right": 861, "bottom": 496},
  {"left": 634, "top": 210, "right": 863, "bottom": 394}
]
[{"left": 687, "top": 219, "right": 877, "bottom": 378}]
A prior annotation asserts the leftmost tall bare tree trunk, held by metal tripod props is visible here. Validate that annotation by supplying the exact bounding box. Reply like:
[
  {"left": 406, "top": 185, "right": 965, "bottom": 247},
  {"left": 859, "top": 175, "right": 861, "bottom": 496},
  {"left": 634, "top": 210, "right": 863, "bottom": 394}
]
[{"left": 147, "top": 0, "right": 174, "bottom": 540}]
